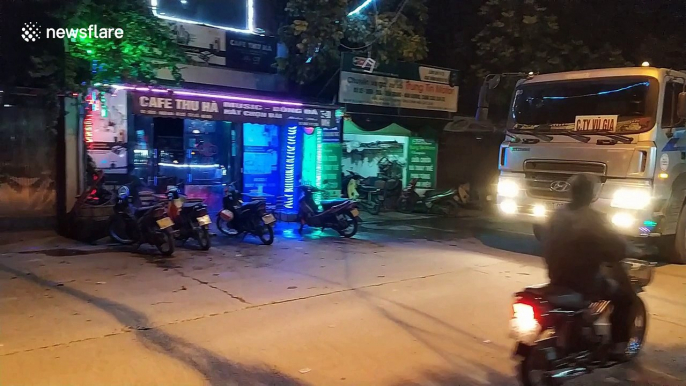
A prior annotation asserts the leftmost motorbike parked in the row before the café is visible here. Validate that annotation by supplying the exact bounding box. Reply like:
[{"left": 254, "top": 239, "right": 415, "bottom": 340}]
[{"left": 109, "top": 185, "right": 174, "bottom": 256}]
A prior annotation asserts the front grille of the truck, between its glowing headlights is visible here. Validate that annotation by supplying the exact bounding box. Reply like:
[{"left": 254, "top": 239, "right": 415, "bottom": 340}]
[{"left": 524, "top": 161, "right": 606, "bottom": 201}]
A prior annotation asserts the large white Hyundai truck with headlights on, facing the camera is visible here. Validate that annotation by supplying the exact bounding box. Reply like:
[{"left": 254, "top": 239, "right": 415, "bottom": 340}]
[{"left": 480, "top": 67, "right": 686, "bottom": 264}]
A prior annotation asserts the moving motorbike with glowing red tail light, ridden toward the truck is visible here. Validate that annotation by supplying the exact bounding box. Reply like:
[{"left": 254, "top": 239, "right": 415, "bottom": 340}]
[{"left": 511, "top": 259, "right": 654, "bottom": 386}]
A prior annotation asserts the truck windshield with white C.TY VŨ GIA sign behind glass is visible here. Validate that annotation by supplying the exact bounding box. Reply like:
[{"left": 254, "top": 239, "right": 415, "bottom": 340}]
[{"left": 509, "top": 77, "right": 659, "bottom": 134}]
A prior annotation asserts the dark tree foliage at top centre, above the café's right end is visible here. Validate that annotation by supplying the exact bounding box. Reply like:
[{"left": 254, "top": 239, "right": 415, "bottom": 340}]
[{"left": 277, "top": 0, "right": 428, "bottom": 84}]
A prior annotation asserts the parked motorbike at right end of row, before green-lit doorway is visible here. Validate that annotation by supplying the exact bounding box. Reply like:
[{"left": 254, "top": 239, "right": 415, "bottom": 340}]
[{"left": 298, "top": 185, "right": 360, "bottom": 238}]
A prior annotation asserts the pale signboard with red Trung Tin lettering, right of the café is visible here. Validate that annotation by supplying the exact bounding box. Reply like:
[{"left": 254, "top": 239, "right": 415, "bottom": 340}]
[{"left": 338, "top": 53, "right": 458, "bottom": 112}]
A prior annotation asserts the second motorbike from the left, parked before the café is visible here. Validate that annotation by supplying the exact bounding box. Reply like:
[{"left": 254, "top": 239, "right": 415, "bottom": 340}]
[{"left": 166, "top": 184, "right": 212, "bottom": 251}]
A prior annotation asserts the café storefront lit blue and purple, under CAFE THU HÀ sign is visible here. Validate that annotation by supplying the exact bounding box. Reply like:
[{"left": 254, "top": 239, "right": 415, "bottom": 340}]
[{"left": 91, "top": 86, "right": 342, "bottom": 211}]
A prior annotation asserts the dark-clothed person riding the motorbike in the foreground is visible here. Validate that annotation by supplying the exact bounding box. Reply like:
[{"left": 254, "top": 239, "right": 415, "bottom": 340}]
[{"left": 543, "top": 174, "right": 636, "bottom": 360}]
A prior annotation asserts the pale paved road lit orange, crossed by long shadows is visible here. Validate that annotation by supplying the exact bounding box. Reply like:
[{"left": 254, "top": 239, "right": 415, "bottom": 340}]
[{"left": 0, "top": 219, "right": 686, "bottom": 386}]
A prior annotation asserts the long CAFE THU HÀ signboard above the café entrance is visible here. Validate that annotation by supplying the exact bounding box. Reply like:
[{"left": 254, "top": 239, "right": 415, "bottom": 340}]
[{"left": 133, "top": 91, "right": 336, "bottom": 127}]
